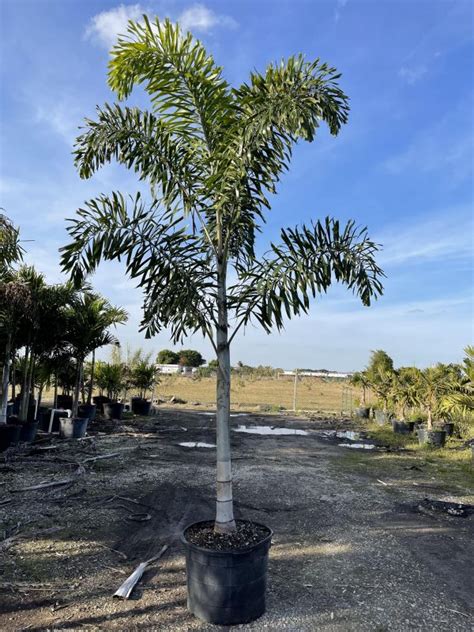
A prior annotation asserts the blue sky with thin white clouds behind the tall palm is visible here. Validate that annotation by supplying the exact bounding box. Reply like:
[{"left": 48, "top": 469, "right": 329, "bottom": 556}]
[{"left": 0, "top": 0, "right": 474, "bottom": 370}]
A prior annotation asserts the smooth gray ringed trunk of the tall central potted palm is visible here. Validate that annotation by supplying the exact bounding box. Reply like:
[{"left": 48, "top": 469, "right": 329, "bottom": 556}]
[{"left": 214, "top": 260, "right": 235, "bottom": 533}]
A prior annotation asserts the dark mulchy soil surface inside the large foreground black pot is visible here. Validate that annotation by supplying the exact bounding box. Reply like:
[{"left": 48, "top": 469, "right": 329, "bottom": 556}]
[{"left": 184, "top": 520, "right": 270, "bottom": 551}]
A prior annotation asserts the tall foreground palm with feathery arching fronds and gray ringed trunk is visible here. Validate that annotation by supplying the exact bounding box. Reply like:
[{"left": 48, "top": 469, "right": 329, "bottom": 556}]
[{"left": 62, "top": 16, "right": 383, "bottom": 533}]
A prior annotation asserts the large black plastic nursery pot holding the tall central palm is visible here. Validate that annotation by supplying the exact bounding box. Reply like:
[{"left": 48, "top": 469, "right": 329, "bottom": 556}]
[{"left": 181, "top": 521, "right": 273, "bottom": 625}]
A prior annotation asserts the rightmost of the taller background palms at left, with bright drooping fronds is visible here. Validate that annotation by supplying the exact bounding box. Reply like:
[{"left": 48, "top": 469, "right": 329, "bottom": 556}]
[{"left": 66, "top": 289, "right": 127, "bottom": 417}]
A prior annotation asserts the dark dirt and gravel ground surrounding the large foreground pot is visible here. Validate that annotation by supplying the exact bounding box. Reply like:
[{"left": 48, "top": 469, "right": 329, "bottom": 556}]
[{"left": 0, "top": 410, "right": 474, "bottom": 632}]
